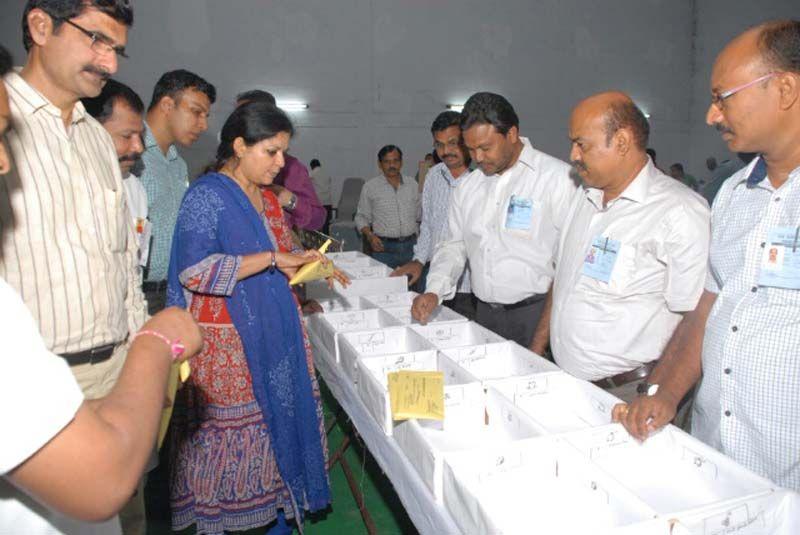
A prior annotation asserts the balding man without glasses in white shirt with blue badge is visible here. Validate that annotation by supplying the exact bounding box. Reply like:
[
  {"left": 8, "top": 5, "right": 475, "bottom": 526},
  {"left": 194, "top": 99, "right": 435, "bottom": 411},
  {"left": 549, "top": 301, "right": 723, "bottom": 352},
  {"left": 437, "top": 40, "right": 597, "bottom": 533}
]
[{"left": 531, "top": 92, "right": 709, "bottom": 400}]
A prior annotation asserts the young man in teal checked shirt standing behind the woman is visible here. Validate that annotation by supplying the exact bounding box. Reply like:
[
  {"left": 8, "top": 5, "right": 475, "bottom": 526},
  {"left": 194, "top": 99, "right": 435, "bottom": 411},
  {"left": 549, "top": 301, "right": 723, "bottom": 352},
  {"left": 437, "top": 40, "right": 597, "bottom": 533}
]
[{"left": 136, "top": 69, "right": 217, "bottom": 314}]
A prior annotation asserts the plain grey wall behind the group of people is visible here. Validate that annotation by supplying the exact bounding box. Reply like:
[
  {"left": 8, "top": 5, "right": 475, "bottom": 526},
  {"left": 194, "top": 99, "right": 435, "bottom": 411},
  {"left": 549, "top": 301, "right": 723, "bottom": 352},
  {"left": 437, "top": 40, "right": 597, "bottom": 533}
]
[{"left": 0, "top": 0, "right": 797, "bottom": 206}]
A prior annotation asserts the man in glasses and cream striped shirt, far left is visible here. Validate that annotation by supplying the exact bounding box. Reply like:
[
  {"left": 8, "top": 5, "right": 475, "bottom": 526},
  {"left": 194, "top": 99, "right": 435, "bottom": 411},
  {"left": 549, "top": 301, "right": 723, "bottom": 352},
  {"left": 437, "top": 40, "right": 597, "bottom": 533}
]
[{"left": 0, "top": 0, "right": 146, "bottom": 399}]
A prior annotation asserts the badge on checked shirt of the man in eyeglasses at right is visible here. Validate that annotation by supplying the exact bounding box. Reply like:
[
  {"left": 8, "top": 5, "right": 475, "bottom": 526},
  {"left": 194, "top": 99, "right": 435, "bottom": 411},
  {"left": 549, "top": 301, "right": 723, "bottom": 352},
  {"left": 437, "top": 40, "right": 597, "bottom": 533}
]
[{"left": 758, "top": 226, "right": 800, "bottom": 290}]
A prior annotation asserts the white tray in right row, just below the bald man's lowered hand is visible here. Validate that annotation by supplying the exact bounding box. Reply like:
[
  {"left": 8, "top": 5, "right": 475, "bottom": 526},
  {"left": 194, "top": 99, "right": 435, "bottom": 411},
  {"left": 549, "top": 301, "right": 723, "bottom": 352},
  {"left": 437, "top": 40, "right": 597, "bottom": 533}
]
[{"left": 440, "top": 340, "right": 559, "bottom": 382}]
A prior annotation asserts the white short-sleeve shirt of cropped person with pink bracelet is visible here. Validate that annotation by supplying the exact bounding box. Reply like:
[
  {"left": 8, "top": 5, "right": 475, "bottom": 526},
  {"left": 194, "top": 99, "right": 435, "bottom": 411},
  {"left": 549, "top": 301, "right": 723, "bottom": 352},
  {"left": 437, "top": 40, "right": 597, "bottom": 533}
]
[{"left": 0, "top": 279, "right": 120, "bottom": 535}]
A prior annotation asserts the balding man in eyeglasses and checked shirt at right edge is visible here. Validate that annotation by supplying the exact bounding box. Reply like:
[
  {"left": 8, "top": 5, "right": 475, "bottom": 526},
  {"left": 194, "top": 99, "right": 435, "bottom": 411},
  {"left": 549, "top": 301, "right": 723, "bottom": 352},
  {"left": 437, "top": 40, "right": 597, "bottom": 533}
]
[{"left": 615, "top": 20, "right": 800, "bottom": 490}]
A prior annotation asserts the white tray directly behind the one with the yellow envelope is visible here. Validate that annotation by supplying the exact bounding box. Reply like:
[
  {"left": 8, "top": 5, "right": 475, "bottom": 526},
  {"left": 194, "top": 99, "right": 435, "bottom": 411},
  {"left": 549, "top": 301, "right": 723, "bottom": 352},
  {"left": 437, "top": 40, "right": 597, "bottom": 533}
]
[{"left": 339, "top": 327, "right": 436, "bottom": 383}]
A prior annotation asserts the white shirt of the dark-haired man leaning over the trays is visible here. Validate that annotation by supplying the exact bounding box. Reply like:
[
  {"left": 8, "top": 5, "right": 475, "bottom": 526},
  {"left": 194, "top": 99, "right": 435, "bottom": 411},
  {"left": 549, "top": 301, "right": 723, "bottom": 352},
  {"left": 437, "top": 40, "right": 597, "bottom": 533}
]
[{"left": 426, "top": 137, "right": 575, "bottom": 304}]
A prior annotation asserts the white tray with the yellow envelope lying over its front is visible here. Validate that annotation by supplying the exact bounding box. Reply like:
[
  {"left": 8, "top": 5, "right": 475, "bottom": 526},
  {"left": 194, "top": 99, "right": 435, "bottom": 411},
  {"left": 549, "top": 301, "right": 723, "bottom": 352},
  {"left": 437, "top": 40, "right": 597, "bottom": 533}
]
[{"left": 356, "top": 351, "right": 480, "bottom": 435}]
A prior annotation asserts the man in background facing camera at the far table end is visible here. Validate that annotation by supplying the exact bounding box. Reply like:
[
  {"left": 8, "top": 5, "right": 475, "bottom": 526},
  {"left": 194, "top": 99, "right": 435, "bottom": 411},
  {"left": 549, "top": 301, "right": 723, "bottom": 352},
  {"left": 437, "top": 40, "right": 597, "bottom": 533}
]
[{"left": 355, "top": 145, "right": 420, "bottom": 268}]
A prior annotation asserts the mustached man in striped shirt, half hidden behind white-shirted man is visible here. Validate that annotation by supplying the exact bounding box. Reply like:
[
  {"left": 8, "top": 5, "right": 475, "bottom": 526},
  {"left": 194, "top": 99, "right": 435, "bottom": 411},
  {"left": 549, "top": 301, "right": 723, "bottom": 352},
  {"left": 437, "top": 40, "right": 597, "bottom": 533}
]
[{"left": 392, "top": 111, "right": 475, "bottom": 318}]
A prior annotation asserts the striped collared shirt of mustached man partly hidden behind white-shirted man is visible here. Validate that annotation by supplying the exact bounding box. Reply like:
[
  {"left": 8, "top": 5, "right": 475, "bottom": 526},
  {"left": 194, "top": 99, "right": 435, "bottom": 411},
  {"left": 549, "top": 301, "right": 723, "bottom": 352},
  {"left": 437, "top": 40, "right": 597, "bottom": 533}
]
[{"left": 414, "top": 162, "right": 470, "bottom": 293}]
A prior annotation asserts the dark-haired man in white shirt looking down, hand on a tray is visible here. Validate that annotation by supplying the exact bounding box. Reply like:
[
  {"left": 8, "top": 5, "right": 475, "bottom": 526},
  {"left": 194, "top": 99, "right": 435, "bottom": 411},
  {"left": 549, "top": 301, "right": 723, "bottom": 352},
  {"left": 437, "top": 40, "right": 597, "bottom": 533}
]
[{"left": 411, "top": 93, "right": 575, "bottom": 347}]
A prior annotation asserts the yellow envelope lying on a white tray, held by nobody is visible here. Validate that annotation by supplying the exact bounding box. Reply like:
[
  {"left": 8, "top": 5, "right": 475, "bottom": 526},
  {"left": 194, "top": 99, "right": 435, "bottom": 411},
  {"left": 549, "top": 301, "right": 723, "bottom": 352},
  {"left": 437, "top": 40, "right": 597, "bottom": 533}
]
[{"left": 387, "top": 370, "right": 444, "bottom": 420}]
